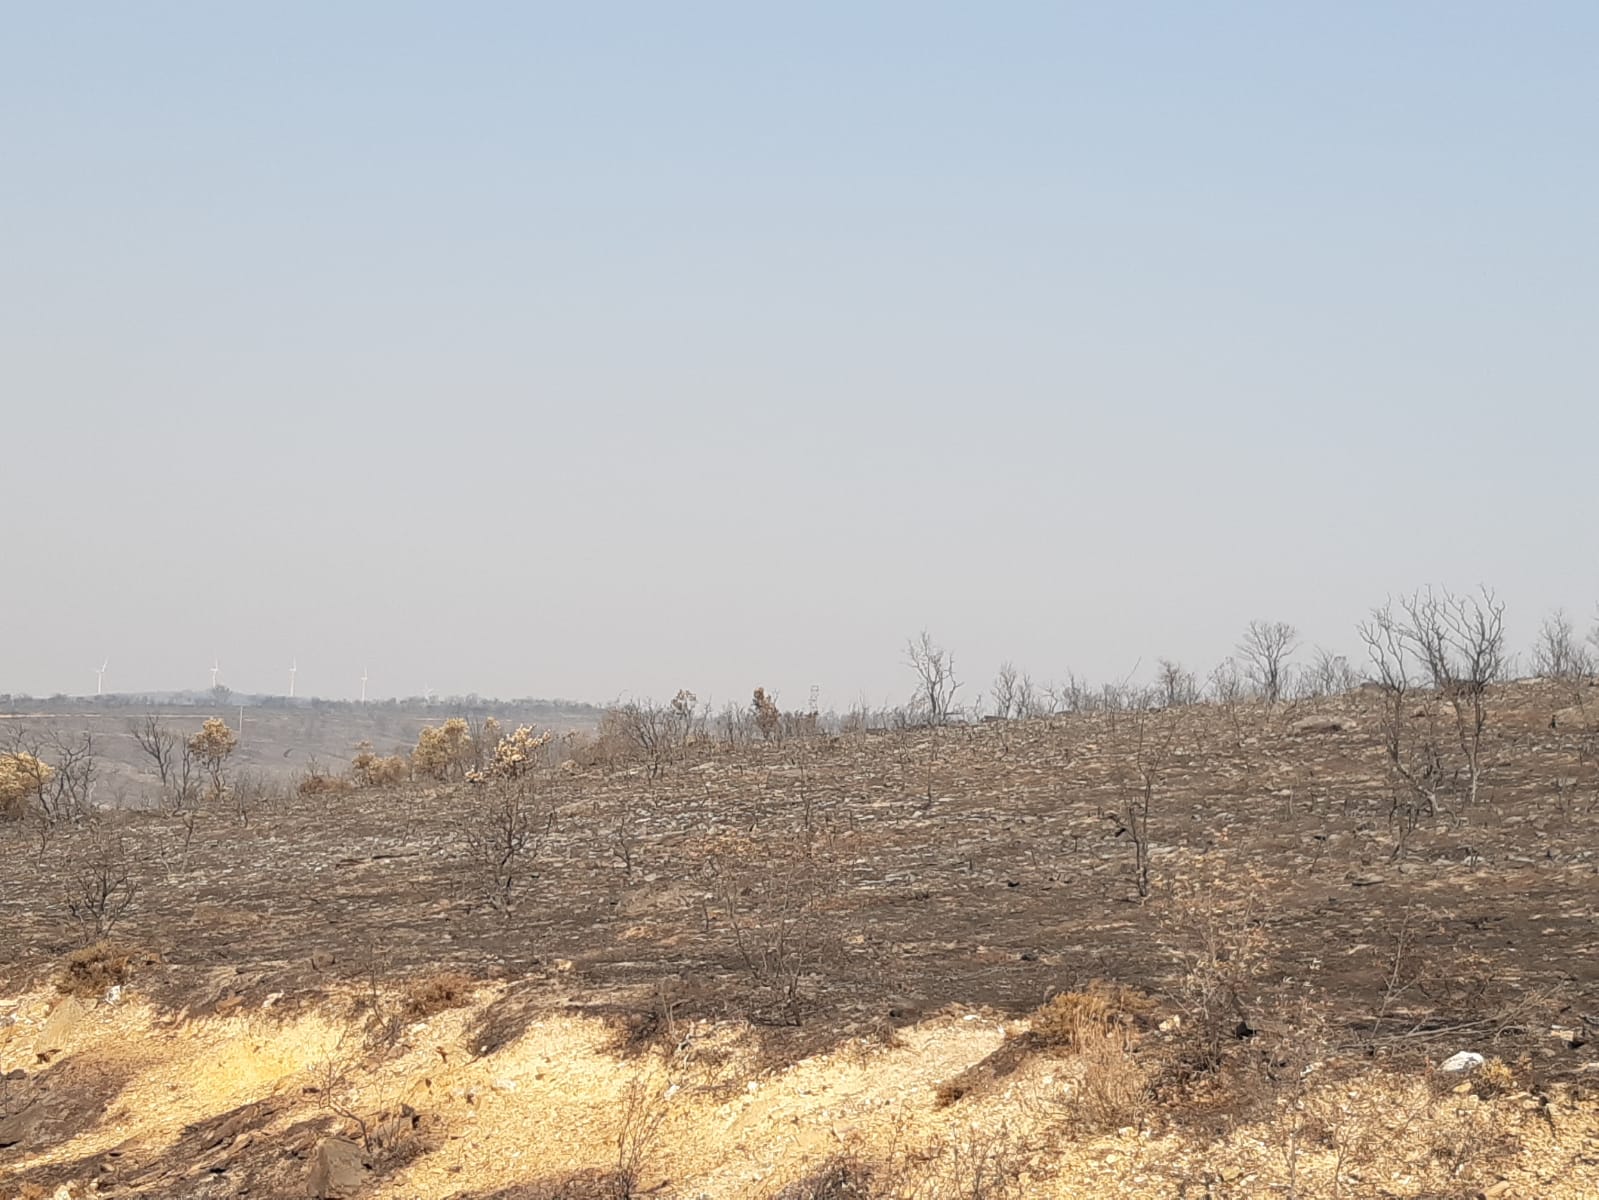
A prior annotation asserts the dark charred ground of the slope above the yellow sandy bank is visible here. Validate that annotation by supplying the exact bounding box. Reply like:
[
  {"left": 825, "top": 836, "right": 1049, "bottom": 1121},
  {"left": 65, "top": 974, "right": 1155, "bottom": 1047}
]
[{"left": 0, "top": 683, "right": 1599, "bottom": 1197}]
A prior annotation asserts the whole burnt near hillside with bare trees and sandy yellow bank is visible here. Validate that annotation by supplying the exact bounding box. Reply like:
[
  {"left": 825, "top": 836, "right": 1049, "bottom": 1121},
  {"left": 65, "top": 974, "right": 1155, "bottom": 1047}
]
[{"left": 0, "top": 620, "right": 1599, "bottom": 1200}]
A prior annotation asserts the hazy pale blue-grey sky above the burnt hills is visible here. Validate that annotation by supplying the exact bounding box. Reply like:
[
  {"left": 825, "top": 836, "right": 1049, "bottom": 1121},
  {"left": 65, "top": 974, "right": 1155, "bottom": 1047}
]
[{"left": 0, "top": 0, "right": 1599, "bottom": 706}]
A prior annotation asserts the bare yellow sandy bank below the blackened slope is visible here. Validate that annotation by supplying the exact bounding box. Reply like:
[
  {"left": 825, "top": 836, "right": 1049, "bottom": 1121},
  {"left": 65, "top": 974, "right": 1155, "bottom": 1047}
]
[{"left": 0, "top": 984, "right": 1599, "bottom": 1200}]
